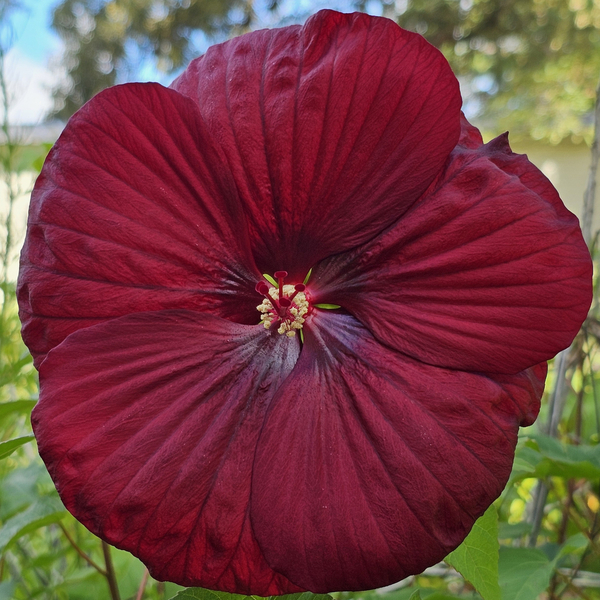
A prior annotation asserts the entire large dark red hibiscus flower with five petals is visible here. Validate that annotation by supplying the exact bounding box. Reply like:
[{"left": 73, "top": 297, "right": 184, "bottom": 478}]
[{"left": 19, "top": 11, "right": 591, "bottom": 595}]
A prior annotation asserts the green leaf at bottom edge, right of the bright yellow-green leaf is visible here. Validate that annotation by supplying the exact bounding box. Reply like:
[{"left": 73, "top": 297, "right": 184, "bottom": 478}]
[{"left": 498, "top": 547, "right": 556, "bottom": 600}]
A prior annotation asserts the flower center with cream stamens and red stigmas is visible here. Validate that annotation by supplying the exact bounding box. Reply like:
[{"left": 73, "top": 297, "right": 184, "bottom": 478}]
[{"left": 256, "top": 271, "right": 310, "bottom": 337}]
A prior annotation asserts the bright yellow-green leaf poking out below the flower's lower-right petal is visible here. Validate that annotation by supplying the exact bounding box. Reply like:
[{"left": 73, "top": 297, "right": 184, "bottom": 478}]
[{"left": 445, "top": 505, "right": 501, "bottom": 600}]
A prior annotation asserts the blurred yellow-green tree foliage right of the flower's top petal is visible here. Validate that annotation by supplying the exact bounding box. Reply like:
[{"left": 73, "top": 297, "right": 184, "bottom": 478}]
[{"left": 366, "top": 0, "right": 600, "bottom": 144}]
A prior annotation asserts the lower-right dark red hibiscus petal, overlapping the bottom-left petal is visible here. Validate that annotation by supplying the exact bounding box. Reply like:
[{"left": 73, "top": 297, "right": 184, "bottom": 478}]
[{"left": 251, "top": 313, "right": 546, "bottom": 592}]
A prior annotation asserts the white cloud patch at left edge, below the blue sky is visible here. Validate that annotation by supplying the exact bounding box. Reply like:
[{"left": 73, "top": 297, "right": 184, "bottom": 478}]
[{"left": 0, "top": 48, "right": 61, "bottom": 125}]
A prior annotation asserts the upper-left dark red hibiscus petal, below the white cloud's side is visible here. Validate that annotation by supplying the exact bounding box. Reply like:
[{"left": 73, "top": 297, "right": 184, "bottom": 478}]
[{"left": 19, "top": 84, "right": 260, "bottom": 364}]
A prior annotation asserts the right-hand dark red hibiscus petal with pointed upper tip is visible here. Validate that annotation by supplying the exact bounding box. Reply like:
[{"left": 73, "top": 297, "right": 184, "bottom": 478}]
[{"left": 311, "top": 121, "right": 592, "bottom": 373}]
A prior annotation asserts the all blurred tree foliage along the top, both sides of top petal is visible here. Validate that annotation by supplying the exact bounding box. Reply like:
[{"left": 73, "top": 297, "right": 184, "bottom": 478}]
[{"left": 53, "top": 0, "right": 600, "bottom": 144}]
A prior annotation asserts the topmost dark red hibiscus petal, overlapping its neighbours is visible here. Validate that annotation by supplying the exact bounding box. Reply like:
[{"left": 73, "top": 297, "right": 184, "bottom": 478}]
[{"left": 173, "top": 10, "right": 461, "bottom": 280}]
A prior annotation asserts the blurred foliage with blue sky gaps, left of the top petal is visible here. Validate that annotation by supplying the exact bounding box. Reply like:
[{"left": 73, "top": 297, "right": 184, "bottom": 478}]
[{"left": 52, "top": 0, "right": 252, "bottom": 119}]
